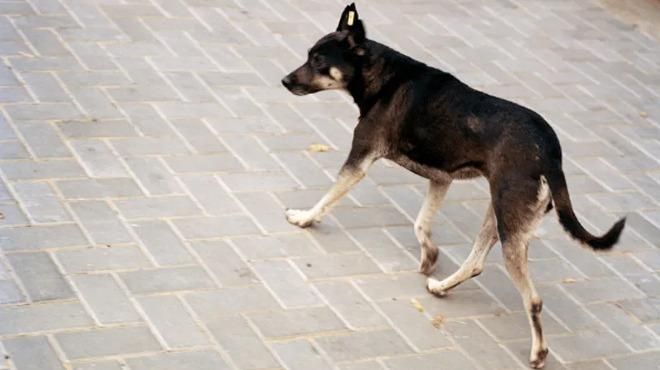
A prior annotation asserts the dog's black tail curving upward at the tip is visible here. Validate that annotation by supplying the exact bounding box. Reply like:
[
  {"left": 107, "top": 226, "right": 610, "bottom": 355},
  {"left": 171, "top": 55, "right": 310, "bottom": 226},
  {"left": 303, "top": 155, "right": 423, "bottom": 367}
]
[{"left": 546, "top": 169, "right": 626, "bottom": 250}]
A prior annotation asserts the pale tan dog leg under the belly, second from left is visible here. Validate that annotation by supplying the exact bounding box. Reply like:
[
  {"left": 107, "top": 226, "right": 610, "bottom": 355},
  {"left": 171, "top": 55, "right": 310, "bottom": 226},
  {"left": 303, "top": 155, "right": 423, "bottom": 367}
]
[{"left": 415, "top": 179, "right": 451, "bottom": 275}]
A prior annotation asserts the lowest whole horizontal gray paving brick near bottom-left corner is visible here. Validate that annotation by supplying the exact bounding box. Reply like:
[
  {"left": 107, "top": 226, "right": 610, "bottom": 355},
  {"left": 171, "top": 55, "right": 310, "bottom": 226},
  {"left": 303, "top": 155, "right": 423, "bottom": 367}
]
[{"left": 55, "top": 326, "right": 160, "bottom": 360}]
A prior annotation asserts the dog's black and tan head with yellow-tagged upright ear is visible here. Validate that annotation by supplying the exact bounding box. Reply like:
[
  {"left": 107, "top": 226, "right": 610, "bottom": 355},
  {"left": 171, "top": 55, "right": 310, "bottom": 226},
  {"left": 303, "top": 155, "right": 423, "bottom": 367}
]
[{"left": 282, "top": 4, "right": 366, "bottom": 95}]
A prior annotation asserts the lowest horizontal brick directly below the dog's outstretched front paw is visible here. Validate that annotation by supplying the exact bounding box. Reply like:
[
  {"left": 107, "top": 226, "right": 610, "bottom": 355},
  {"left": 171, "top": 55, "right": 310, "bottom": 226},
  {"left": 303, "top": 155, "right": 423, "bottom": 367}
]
[{"left": 249, "top": 307, "right": 344, "bottom": 338}]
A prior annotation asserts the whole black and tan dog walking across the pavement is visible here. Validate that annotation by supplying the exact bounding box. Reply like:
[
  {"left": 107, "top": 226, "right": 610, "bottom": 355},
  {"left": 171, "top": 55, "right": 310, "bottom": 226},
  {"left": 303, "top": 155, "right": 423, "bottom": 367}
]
[{"left": 282, "top": 4, "right": 625, "bottom": 368}]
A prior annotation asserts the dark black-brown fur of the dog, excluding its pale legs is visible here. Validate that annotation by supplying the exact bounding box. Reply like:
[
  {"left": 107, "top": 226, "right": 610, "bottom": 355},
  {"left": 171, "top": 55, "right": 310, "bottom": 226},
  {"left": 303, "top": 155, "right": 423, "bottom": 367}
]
[{"left": 282, "top": 4, "right": 625, "bottom": 367}]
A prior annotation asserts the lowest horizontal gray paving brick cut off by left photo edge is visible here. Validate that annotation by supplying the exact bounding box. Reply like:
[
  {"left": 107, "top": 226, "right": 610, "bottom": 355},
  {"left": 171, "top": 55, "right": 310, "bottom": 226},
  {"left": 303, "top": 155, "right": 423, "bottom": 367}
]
[{"left": 0, "top": 301, "right": 92, "bottom": 335}]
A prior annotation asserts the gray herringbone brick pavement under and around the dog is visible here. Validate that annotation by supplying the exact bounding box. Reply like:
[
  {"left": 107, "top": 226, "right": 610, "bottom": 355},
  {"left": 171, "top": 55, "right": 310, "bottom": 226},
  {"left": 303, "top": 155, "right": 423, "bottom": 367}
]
[{"left": 0, "top": 0, "right": 660, "bottom": 370}]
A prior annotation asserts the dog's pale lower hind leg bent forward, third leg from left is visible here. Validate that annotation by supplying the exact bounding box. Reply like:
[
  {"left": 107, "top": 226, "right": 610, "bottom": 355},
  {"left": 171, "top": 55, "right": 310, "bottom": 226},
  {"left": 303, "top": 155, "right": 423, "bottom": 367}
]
[{"left": 426, "top": 205, "right": 498, "bottom": 296}]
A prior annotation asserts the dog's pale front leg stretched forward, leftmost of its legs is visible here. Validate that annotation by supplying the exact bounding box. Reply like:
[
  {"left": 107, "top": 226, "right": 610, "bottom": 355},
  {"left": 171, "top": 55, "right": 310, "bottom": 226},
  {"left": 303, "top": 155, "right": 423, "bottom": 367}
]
[{"left": 286, "top": 150, "right": 376, "bottom": 227}]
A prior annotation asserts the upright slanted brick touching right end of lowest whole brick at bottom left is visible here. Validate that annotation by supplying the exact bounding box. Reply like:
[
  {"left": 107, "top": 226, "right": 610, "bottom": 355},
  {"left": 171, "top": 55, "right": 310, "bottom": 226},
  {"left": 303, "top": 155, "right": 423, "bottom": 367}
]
[{"left": 138, "top": 296, "right": 210, "bottom": 348}]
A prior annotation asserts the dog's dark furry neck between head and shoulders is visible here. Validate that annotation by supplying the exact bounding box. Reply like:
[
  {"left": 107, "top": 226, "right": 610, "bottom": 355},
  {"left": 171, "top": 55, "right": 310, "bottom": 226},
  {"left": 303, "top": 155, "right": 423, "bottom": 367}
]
[{"left": 347, "top": 40, "right": 426, "bottom": 117}]
